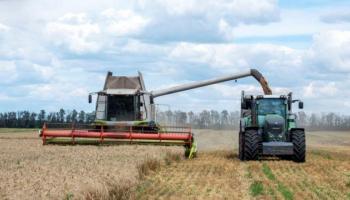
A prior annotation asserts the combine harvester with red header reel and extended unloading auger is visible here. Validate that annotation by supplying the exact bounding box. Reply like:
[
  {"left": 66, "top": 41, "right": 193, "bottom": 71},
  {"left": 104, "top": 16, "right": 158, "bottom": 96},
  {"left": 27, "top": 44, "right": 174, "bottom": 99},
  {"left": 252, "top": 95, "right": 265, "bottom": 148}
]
[{"left": 40, "top": 69, "right": 272, "bottom": 158}]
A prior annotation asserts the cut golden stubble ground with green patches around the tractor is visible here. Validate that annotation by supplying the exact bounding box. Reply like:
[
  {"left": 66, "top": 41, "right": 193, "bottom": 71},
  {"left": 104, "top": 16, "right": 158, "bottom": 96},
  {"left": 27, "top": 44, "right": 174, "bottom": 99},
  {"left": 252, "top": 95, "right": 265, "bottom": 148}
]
[{"left": 137, "top": 130, "right": 350, "bottom": 200}]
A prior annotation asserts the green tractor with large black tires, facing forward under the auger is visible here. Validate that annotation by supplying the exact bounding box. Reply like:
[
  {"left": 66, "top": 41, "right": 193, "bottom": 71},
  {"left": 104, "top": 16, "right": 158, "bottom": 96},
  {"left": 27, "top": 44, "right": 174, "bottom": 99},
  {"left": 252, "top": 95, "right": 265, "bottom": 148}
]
[{"left": 239, "top": 91, "right": 306, "bottom": 162}]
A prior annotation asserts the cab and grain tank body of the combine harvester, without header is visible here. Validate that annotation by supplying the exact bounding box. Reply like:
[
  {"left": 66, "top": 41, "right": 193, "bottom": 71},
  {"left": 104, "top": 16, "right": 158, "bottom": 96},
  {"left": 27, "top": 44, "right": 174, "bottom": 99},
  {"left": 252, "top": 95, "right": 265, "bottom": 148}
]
[{"left": 89, "top": 72, "right": 151, "bottom": 125}]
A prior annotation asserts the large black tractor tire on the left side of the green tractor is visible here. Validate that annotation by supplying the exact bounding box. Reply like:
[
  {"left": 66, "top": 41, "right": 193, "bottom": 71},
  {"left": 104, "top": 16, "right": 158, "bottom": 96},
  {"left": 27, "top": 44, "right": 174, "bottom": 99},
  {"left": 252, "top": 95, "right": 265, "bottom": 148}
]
[{"left": 243, "top": 130, "right": 261, "bottom": 160}]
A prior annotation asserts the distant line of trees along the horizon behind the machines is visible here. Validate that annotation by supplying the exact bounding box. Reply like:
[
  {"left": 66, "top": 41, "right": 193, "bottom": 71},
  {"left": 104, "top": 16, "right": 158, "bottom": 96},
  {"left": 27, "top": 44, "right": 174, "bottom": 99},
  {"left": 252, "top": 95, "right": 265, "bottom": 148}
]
[{"left": 0, "top": 109, "right": 350, "bottom": 130}]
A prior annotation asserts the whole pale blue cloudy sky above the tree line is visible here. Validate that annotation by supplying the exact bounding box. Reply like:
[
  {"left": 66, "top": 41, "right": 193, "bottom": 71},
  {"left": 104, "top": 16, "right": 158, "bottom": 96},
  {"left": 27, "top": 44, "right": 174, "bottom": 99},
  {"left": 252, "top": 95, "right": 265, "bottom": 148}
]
[{"left": 0, "top": 0, "right": 350, "bottom": 114}]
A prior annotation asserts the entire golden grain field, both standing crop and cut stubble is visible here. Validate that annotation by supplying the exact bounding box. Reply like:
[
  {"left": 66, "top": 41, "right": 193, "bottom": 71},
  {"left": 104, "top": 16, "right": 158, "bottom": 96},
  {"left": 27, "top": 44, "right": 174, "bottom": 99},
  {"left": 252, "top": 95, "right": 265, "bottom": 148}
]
[{"left": 0, "top": 130, "right": 350, "bottom": 199}]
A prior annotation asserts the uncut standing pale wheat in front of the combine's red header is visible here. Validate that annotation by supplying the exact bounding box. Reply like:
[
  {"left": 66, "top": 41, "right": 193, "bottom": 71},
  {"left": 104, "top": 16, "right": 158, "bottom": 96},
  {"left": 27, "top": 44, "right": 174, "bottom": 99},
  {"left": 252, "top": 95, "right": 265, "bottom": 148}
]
[{"left": 0, "top": 130, "right": 183, "bottom": 199}]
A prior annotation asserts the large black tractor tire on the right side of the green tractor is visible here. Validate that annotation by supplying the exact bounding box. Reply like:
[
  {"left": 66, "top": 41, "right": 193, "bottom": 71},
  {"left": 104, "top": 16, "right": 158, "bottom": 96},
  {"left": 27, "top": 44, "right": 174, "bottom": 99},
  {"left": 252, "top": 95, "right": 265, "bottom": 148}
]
[{"left": 292, "top": 130, "right": 306, "bottom": 163}]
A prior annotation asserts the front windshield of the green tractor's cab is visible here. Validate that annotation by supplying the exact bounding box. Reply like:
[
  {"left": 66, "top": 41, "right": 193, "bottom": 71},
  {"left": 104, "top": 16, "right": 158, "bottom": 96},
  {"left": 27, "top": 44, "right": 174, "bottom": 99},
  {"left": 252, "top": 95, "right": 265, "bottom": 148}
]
[{"left": 258, "top": 99, "right": 286, "bottom": 116}]
